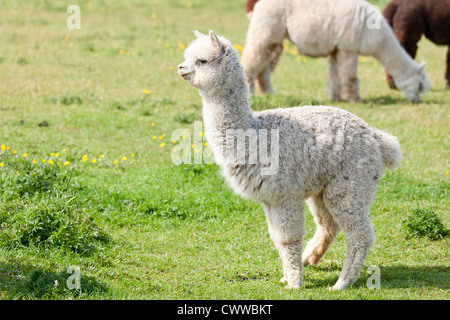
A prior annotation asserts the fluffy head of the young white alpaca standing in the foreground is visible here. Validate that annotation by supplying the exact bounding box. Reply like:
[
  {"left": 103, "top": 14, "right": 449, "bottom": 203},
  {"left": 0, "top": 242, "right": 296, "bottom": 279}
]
[{"left": 178, "top": 31, "right": 243, "bottom": 90}]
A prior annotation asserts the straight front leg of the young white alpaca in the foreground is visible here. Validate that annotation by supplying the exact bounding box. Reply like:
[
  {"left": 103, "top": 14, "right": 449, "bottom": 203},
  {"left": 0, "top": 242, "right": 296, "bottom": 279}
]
[{"left": 264, "top": 200, "right": 303, "bottom": 289}]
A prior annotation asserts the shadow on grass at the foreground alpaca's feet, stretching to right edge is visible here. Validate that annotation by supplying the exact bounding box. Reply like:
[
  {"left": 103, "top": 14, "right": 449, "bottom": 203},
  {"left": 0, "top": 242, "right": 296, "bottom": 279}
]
[{"left": 305, "top": 265, "right": 450, "bottom": 290}]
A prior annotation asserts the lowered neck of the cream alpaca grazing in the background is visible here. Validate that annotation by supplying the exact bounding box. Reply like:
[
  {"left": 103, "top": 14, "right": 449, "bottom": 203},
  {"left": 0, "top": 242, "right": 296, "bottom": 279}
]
[{"left": 374, "top": 30, "right": 417, "bottom": 83}]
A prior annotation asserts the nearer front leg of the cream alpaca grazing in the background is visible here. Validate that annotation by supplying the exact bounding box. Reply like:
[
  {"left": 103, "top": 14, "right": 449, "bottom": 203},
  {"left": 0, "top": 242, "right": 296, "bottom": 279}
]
[{"left": 337, "top": 50, "right": 361, "bottom": 103}]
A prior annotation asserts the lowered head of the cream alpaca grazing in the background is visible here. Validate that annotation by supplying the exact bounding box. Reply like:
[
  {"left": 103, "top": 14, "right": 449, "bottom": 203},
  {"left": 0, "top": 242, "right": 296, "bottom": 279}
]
[{"left": 394, "top": 62, "right": 430, "bottom": 103}]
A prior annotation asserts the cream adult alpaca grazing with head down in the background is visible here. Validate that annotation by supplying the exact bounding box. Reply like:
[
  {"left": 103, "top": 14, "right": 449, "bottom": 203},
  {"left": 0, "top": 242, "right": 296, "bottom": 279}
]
[{"left": 241, "top": 0, "right": 430, "bottom": 102}]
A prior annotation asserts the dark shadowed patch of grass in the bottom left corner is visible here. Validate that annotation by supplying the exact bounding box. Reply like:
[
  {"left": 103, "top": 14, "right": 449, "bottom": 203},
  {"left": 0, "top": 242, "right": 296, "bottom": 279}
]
[{"left": 0, "top": 260, "right": 108, "bottom": 299}]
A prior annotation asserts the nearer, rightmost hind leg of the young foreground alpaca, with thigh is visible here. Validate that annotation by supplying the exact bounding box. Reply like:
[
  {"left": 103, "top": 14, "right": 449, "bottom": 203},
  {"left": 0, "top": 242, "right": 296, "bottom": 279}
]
[{"left": 324, "top": 175, "right": 381, "bottom": 290}]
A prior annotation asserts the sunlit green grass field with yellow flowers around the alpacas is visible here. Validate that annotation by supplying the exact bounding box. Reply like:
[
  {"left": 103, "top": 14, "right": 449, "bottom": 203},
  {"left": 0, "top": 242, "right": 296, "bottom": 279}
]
[{"left": 0, "top": 0, "right": 450, "bottom": 299}]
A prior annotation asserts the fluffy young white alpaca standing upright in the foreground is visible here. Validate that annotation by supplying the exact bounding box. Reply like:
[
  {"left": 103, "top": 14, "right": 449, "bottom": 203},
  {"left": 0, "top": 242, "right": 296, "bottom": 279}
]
[{"left": 178, "top": 31, "right": 401, "bottom": 289}]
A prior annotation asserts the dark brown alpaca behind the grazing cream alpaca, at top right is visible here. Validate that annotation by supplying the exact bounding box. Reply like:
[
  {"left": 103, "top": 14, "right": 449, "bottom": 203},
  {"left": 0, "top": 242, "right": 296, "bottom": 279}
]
[{"left": 382, "top": 0, "right": 450, "bottom": 89}]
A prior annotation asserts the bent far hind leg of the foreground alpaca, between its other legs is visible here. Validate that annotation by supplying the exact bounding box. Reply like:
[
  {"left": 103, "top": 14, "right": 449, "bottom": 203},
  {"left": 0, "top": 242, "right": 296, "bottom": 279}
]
[{"left": 302, "top": 193, "right": 339, "bottom": 266}]
